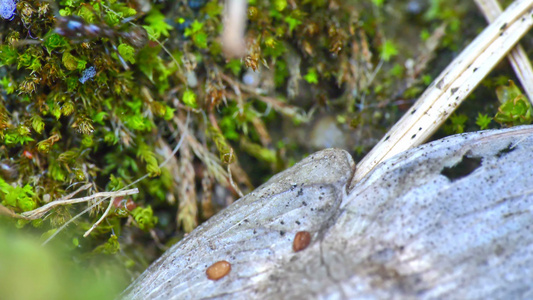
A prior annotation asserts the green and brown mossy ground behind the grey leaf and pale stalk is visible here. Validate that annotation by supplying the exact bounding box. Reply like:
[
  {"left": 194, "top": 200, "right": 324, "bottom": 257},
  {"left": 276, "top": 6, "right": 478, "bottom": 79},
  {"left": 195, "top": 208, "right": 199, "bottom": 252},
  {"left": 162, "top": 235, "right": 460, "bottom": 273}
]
[{"left": 0, "top": 0, "right": 532, "bottom": 296}]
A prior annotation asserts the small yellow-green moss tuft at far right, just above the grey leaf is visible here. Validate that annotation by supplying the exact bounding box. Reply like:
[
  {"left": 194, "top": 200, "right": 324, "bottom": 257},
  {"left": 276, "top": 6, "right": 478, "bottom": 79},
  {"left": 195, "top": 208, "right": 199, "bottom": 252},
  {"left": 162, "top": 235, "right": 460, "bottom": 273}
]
[{"left": 494, "top": 80, "right": 533, "bottom": 126}]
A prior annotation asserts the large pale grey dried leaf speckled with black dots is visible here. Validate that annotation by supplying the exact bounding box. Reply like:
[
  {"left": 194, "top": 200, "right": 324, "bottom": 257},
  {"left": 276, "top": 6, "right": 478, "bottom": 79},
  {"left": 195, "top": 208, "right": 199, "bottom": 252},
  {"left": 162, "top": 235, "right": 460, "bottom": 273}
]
[{"left": 123, "top": 126, "right": 533, "bottom": 299}]
